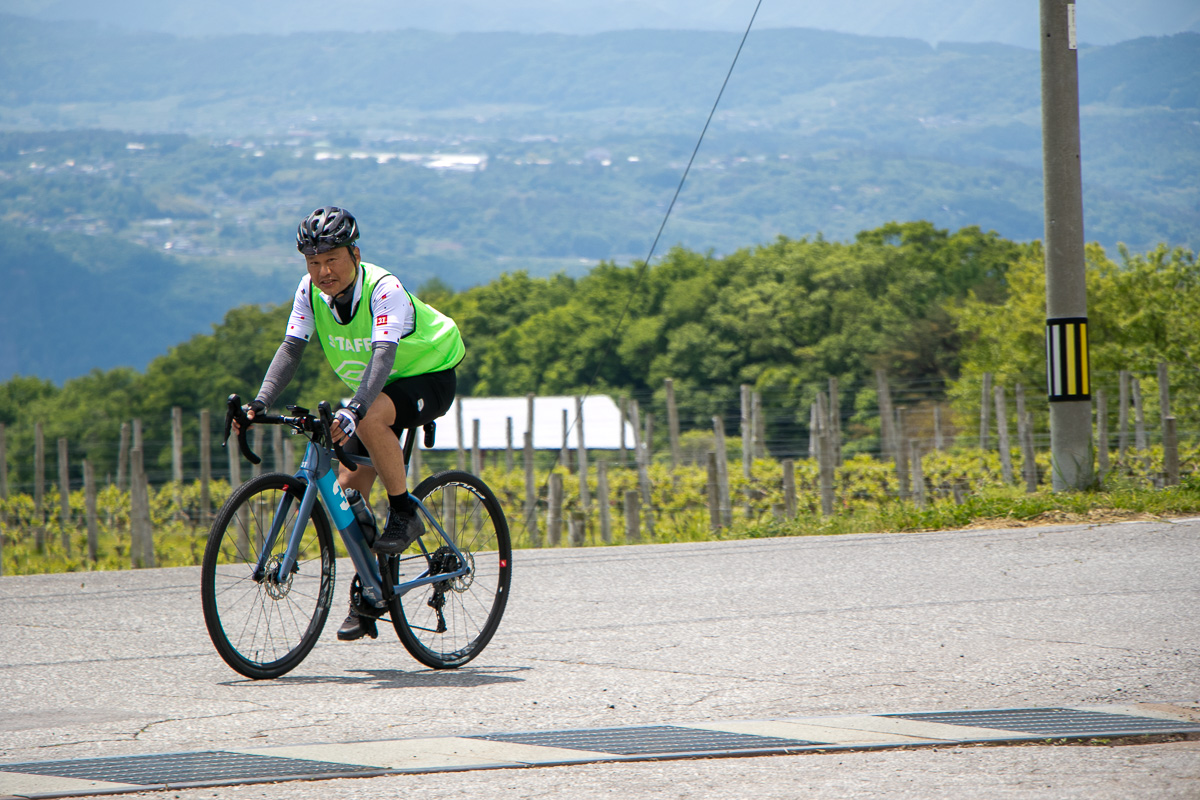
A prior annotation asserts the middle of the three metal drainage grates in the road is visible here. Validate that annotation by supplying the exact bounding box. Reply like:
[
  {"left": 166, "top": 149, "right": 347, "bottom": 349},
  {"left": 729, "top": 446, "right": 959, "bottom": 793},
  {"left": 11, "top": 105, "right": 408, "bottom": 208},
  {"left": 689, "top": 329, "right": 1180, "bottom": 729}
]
[{"left": 470, "top": 726, "right": 826, "bottom": 756}]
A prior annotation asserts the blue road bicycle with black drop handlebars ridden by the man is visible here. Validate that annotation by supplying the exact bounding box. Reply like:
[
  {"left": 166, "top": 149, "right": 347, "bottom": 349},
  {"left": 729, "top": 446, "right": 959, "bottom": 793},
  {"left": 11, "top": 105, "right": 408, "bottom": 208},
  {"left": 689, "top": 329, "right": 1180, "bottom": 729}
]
[{"left": 200, "top": 395, "right": 512, "bottom": 679}]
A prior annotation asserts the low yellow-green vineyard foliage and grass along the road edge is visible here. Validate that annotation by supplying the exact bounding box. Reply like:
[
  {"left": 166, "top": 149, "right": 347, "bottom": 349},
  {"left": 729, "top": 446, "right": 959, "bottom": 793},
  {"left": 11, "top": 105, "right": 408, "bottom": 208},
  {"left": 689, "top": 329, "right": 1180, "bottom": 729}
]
[{"left": 0, "top": 446, "right": 1200, "bottom": 575}]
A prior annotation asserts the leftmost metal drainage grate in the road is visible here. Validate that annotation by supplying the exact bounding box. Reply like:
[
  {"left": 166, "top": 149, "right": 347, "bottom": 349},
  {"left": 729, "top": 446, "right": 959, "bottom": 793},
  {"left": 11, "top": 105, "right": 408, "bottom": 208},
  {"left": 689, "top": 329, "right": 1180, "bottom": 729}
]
[{"left": 0, "top": 752, "right": 370, "bottom": 786}]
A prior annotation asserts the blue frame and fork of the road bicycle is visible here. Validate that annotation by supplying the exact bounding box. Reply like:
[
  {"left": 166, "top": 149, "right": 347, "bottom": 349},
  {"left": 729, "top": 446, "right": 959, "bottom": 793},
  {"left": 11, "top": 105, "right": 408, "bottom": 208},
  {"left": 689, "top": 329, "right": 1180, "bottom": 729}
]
[{"left": 254, "top": 441, "right": 469, "bottom": 607}]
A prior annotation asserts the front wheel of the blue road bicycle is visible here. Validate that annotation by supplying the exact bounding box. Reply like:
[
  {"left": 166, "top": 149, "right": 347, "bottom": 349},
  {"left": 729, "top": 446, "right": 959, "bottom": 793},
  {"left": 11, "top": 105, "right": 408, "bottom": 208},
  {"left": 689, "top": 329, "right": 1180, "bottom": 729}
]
[{"left": 200, "top": 473, "right": 335, "bottom": 679}]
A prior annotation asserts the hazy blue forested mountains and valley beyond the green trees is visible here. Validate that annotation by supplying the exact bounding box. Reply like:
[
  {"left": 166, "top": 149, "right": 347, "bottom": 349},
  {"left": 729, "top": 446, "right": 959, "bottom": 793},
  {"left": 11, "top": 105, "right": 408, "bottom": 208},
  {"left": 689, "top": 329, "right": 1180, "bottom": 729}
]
[{"left": 0, "top": 16, "right": 1200, "bottom": 380}]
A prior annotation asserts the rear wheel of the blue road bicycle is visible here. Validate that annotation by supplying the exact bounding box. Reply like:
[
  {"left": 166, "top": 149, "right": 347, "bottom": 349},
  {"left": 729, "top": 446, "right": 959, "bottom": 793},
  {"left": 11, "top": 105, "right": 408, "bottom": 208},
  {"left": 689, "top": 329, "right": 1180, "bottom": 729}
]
[{"left": 385, "top": 470, "right": 512, "bottom": 669}]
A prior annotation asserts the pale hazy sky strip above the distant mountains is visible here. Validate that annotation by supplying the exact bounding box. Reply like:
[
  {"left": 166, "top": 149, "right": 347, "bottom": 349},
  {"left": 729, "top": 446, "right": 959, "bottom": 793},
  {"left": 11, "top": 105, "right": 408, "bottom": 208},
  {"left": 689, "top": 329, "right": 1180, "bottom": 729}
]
[{"left": 0, "top": 0, "right": 1200, "bottom": 48}]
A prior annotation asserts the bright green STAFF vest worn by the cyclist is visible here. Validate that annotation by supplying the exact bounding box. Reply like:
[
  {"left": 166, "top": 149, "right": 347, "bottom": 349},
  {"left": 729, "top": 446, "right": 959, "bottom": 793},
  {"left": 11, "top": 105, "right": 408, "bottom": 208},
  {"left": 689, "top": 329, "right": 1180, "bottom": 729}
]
[{"left": 308, "top": 261, "right": 467, "bottom": 391}]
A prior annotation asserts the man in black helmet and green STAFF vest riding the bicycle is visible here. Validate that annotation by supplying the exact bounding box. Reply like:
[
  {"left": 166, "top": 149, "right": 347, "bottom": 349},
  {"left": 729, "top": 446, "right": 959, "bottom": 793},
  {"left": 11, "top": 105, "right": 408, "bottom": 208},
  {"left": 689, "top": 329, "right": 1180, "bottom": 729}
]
[{"left": 235, "top": 206, "right": 466, "bottom": 642}]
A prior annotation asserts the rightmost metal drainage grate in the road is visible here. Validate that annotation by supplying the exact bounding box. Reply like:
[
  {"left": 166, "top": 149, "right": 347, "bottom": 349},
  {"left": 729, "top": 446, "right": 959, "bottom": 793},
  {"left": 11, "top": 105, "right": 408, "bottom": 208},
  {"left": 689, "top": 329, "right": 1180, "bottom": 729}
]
[{"left": 880, "top": 709, "right": 1200, "bottom": 736}]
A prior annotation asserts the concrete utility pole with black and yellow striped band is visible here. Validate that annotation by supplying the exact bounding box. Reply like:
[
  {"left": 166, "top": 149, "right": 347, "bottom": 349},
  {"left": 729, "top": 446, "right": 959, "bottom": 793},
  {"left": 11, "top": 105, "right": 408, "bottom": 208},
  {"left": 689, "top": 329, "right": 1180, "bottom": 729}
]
[{"left": 1040, "top": 0, "right": 1094, "bottom": 492}]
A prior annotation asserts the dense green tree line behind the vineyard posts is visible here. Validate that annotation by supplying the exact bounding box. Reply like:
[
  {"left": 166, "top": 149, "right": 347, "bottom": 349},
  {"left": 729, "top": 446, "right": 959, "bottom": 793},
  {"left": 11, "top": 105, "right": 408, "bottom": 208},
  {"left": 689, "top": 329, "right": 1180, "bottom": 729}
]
[{"left": 0, "top": 222, "right": 1200, "bottom": 494}]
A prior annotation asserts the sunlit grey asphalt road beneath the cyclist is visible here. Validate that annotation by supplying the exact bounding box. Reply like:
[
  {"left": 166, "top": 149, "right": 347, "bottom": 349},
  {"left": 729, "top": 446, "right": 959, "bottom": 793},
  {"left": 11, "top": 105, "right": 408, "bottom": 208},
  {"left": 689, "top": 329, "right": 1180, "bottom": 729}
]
[{"left": 0, "top": 521, "right": 1200, "bottom": 800}]
